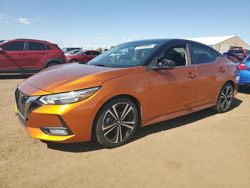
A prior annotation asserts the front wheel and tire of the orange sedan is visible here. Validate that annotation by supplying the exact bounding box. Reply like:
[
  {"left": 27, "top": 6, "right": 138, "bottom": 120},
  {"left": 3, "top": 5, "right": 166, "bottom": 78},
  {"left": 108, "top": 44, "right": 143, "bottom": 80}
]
[{"left": 95, "top": 97, "right": 140, "bottom": 148}]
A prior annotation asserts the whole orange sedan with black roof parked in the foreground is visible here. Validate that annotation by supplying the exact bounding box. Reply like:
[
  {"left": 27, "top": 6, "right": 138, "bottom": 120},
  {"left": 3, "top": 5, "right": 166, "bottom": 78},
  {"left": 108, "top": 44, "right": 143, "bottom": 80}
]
[{"left": 15, "top": 39, "right": 238, "bottom": 148}]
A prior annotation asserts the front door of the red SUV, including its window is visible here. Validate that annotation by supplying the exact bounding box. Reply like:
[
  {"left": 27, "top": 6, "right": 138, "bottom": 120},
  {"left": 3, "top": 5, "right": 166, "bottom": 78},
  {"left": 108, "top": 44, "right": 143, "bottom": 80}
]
[{"left": 0, "top": 41, "right": 25, "bottom": 72}]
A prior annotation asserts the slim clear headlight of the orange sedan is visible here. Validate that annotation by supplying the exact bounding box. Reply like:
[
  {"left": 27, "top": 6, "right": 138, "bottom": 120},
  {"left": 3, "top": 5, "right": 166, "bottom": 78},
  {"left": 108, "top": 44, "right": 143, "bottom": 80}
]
[{"left": 39, "top": 87, "right": 100, "bottom": 104}]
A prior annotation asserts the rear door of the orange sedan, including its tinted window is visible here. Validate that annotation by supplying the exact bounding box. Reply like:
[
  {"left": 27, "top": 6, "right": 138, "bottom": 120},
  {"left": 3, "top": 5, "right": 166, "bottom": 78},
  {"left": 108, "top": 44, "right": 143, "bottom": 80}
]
[{"left": 190, "top": 43, "right": 226, "bottom": 106}]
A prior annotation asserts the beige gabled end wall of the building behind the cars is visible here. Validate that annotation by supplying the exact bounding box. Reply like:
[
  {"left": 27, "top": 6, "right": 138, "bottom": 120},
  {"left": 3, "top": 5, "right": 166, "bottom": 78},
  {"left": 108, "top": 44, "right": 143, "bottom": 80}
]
[{"left": 215, "top": 36, "right": 250, "bottom": 53}]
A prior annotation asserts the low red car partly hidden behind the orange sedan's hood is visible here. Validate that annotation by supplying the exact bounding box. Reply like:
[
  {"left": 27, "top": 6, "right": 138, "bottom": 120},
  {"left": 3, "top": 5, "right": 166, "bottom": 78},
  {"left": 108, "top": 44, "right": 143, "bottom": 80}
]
[{"left": 66, "top": 50, "right": 101, "bottom": 63}]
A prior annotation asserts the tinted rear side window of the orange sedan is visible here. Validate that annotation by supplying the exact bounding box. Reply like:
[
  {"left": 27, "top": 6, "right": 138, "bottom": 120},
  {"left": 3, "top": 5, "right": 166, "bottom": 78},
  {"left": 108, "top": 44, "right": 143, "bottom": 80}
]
[{"left": 191, "top": 44, "right": 219, "bottom": 64}]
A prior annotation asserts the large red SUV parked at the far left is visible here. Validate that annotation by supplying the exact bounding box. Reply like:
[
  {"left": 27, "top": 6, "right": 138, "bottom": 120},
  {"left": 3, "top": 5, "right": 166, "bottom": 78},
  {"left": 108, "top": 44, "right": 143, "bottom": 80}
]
[{"left": 0, "top": 39, "right": 66, "bottom": 73}]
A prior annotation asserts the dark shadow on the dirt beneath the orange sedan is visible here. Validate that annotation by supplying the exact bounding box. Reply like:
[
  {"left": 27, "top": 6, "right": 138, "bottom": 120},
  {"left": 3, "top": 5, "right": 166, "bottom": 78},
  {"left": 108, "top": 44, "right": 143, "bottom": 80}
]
[{"left": 43, "top": 98, "right": 242, "bottom": 153}]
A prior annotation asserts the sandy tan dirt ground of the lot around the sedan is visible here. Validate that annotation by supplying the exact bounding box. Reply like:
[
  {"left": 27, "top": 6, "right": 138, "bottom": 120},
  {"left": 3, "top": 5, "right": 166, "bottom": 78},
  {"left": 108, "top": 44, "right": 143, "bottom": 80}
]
[{"left": 0, "top": 76, "right": 250, "bottom": 188}]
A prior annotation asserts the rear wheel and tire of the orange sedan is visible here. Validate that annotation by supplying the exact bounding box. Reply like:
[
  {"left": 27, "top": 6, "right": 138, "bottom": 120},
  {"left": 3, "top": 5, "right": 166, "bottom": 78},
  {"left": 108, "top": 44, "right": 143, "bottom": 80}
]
[{"left": 213, "top": 82, "right": 234, "bottom": 113}]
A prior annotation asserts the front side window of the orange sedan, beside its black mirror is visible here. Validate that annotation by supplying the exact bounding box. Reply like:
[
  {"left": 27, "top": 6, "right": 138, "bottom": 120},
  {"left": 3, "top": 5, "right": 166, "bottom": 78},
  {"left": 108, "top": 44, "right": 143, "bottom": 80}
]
[{"left": 161, "top": 45, "right": 188, "bottom": 66}]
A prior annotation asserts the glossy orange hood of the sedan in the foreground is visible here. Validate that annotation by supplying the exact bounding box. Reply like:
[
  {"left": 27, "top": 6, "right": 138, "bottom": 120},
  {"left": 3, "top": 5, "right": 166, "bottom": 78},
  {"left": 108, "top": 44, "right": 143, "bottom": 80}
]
[{"left": 21, "top": 63, "right": 130, "bottom": 93}]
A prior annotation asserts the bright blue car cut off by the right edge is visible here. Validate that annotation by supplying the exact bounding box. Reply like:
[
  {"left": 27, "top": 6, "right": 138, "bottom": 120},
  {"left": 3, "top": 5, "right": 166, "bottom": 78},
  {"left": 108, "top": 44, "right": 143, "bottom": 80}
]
[{"left": 239, "top": 55, "right": 250, "bottom": 86}]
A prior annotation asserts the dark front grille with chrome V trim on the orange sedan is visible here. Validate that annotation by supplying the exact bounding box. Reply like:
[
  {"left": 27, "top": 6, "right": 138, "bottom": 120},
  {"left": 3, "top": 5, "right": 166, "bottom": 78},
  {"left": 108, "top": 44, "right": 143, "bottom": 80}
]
[{"left": 15, "top": 89, "right": 41, "bottom": 120}]
